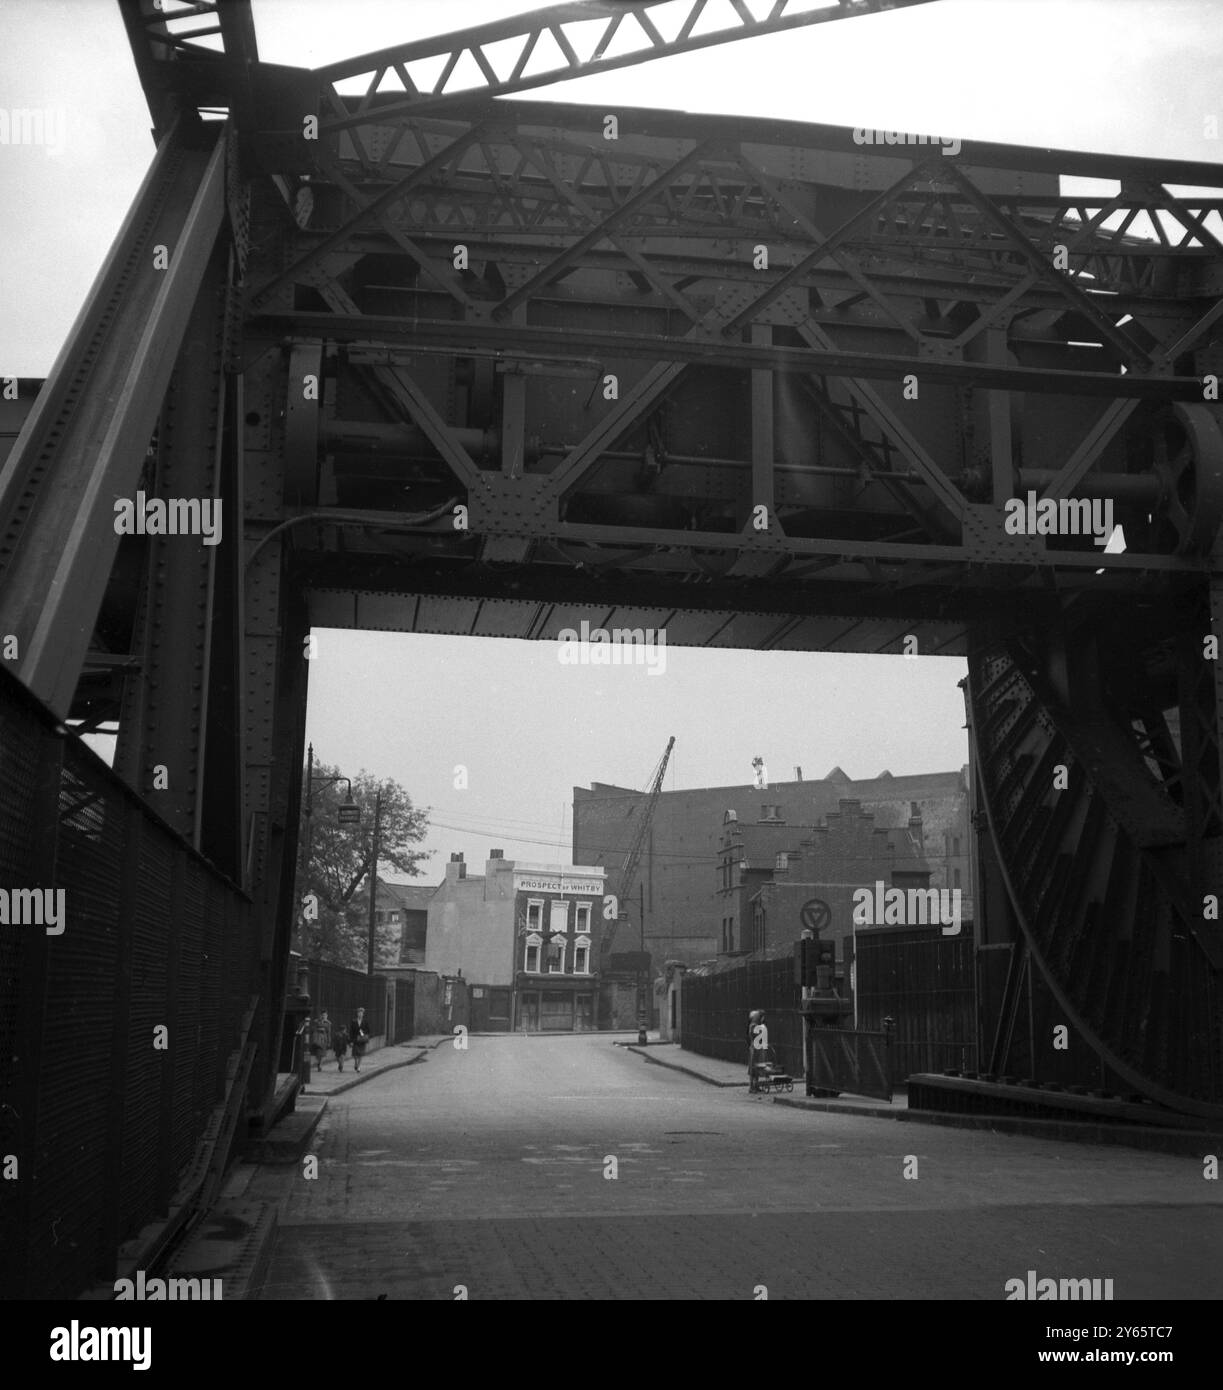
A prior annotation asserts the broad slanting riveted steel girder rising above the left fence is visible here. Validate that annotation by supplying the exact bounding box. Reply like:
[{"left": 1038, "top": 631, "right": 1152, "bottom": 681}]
[{"left": 0, "top": 119, "right": 225, "bottom": 716}]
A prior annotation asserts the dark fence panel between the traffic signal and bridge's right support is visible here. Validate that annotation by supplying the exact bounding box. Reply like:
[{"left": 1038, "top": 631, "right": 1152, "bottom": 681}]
[{"left": 856, "top": 924, "right": 977, "bottom": 1086}]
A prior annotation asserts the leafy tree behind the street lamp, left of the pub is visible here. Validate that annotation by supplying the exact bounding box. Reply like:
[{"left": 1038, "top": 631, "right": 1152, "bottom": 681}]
[{"left": 295, "top": 763, "right": 432, "bottom": 970}]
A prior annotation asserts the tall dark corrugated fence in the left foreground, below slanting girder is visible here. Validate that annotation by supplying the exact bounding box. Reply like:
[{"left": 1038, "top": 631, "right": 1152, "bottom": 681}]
[{"left": 0, "top": 670, "right": 260, "bottom": 1298}]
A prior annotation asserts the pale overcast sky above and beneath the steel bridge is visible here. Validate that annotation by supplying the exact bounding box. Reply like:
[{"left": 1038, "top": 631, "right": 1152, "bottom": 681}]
[{"left": 0, "top": 0, "right": 1223, "bottom": 881}]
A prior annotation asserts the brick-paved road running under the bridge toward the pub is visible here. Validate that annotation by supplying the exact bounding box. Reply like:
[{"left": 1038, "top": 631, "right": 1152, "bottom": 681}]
[{"left": 250, "top": 1036, "right": 1223, "bottom": 1300}]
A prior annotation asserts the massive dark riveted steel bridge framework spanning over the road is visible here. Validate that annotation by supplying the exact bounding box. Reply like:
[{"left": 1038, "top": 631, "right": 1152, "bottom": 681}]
[{"left": 0, "top": 0, "right": 1223, "bottom": 1295}]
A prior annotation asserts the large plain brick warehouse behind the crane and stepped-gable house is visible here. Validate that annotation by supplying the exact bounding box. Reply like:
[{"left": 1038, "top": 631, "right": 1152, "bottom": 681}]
[{"left": 573, "top": 767, "right": 971, "bottom": 966}]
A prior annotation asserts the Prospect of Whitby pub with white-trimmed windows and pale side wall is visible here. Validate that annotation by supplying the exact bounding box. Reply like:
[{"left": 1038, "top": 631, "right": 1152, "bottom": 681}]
[{"left": 425, "top": 849, "right": 603, "bottom": 1031}]
